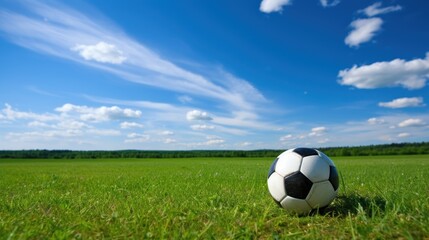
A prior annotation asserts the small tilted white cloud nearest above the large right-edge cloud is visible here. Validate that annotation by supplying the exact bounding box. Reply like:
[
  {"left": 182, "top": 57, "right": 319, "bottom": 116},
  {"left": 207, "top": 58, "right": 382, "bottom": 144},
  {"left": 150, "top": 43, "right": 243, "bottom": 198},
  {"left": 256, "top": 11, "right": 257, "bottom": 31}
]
[{"left": 344, "top": 18, "right": 383, "bottom": 47}]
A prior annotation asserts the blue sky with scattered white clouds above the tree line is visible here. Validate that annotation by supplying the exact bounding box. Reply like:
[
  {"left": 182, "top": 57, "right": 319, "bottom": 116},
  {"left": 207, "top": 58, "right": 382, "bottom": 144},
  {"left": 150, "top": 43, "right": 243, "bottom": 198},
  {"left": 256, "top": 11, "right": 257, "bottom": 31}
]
[{"left": 0, "top": 0, "right": 429, "bottom": 150}]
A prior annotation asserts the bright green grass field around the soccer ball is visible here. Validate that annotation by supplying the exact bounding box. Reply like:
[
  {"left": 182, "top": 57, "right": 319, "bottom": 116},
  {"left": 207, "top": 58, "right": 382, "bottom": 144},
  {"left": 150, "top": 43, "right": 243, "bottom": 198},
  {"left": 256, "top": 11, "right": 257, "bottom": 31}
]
[{"left": 0, "top": 155, "right": 429, "bottom": 239}]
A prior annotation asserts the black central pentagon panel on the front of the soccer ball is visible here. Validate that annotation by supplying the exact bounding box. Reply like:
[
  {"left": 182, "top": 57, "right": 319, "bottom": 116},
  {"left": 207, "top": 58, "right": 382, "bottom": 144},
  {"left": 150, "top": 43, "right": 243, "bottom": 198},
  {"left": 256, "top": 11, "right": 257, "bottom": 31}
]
[{"left": 285, "top": 172, "right": 313, "bottom": 199}]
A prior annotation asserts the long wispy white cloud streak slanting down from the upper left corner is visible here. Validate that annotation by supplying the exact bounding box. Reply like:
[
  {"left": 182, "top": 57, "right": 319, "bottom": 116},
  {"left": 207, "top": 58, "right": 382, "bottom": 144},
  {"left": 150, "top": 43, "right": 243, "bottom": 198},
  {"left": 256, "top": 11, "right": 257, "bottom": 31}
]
[{"left": 0, "top": 0, "right": 265, "bottom": 110}]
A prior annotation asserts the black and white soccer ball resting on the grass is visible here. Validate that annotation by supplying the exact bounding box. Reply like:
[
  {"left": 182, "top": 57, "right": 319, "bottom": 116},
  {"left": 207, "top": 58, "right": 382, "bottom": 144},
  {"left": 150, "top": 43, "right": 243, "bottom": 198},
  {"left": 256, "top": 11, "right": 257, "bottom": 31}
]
[{"left": 267, "top": 148, "right": 340, "bottom": 214}]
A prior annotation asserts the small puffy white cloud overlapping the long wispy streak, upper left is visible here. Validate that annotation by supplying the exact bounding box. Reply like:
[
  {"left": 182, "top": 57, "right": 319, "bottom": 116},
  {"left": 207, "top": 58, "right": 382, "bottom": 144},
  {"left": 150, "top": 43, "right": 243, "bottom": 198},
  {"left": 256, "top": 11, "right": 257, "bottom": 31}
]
[{"left": 71, "top": 42, "right": 127, "bottom": 64}]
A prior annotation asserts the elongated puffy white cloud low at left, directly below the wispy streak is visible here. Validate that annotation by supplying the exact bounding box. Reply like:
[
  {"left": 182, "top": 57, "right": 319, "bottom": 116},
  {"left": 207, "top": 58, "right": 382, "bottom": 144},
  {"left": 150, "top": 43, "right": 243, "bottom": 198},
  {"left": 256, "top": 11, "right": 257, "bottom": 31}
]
[{"left": 55, "top": 103, "right": 142, "bottom": 122}]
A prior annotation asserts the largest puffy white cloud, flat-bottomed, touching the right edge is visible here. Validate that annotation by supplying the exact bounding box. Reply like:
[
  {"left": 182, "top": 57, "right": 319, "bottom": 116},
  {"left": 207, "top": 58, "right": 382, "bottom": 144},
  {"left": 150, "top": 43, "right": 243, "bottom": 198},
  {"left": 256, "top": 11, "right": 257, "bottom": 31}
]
[{"left": 338, "top": 53, "right": 429, "bottom": 89}]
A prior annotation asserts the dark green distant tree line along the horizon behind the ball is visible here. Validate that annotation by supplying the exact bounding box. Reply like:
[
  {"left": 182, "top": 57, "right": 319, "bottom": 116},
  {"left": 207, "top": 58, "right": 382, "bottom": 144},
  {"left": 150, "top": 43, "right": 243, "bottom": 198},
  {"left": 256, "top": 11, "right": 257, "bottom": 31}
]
[{"left": 0, "top": 142, "right": 429, "bottom": 159}]
